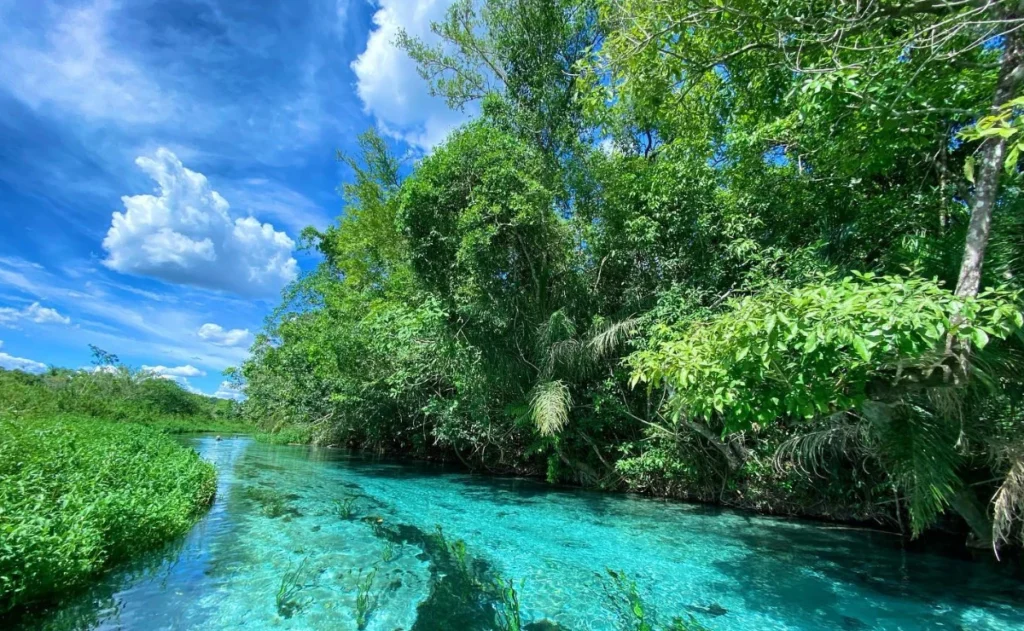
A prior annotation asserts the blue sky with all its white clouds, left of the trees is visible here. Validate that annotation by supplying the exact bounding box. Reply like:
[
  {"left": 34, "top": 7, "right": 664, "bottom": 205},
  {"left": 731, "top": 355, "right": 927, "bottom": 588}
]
[{"left": 0, "top": 0, "right": 466, "bottom": 396}]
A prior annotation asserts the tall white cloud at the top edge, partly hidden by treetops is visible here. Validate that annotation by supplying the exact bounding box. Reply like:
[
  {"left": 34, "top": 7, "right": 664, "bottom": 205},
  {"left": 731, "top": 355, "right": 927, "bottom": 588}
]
[{"left": 351, "top": 0, "right": 469, "bottom": 150}]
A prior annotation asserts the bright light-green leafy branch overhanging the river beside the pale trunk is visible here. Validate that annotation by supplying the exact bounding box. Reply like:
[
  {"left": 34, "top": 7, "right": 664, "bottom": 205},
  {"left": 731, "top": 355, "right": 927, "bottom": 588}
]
[{"left": 631, "top": 274, "right": 1024, "bottom": 431}]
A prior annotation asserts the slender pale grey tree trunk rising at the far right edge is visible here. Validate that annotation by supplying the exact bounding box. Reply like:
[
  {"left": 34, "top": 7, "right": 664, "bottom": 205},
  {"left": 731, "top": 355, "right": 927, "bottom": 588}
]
[{"left": 956, "top": 22, "right": 1024, "bottom": 297}]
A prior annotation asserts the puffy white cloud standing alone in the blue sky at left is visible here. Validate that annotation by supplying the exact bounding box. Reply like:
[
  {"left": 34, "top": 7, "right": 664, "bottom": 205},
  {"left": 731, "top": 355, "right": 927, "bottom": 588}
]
[{"left": 103, "top": 149, "right": 298, "bottom": 297}]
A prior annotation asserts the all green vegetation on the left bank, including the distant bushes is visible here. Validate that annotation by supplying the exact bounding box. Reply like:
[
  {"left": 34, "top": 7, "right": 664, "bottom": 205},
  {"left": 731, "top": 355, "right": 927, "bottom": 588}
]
[{"left": 0, "top": 348, "right": 235, "bottom": 622}]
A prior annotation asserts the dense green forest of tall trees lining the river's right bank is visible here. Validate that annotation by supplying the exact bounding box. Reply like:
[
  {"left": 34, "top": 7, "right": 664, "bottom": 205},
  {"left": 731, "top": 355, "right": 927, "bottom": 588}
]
[{"left": 234, "top": 0, "right": 1024, "bottom": 551}]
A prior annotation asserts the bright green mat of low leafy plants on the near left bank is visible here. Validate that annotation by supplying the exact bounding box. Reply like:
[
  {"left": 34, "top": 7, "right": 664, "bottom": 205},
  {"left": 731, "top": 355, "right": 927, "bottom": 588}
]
[{"left": 0, "top": 414, "right": 215, "bottom": 616}]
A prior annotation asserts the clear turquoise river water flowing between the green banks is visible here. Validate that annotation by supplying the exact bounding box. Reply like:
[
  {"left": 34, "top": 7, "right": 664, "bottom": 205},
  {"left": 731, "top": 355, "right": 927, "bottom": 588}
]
[{"left": 14, "top": 438, "right": 1024, "bottom": 631}]
